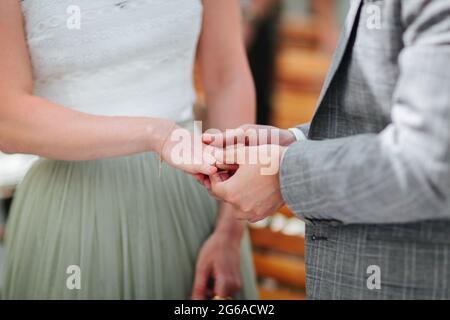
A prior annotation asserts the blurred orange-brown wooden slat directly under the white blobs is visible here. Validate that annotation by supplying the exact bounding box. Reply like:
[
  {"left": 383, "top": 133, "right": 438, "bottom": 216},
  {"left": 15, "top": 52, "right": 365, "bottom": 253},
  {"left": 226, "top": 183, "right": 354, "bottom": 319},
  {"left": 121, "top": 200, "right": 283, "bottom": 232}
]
[{"left": 250, "top": 228, "right": 305, "bottom": 257}]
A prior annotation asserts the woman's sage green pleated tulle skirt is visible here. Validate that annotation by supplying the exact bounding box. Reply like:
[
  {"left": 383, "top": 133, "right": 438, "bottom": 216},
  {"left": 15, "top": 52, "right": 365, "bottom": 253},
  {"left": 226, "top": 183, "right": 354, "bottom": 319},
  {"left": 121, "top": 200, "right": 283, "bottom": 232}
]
[{"left": 2, "top": 149, "right": 257, "bottom": 299}]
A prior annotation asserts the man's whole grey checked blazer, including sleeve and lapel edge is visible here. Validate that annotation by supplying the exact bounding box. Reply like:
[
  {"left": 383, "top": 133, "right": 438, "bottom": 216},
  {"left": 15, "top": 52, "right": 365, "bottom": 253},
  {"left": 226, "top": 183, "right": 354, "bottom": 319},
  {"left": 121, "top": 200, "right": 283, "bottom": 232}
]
[{"left": 280, "top": 0, "right": 450, "bottom": 299}]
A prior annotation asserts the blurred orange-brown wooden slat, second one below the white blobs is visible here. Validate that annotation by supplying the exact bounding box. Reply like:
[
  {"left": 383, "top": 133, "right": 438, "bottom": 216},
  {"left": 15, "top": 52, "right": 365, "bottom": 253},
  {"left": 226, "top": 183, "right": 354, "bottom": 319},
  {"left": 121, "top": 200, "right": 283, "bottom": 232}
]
[{"left": 253, "top": 252, "right": 305, "bottom": 289}]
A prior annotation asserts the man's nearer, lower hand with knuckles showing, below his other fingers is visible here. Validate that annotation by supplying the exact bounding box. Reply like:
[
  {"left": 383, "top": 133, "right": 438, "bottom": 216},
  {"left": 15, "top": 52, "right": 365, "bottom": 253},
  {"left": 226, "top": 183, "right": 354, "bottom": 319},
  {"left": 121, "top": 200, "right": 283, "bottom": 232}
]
[{"left": 209, "top": 145, "right": 286, "bottom": 222}]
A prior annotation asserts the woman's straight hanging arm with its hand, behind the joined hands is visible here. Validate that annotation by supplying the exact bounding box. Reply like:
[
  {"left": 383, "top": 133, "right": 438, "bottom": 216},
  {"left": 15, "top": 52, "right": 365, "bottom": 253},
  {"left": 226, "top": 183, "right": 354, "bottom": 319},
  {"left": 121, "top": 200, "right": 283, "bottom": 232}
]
[{"left": 192, "top": 0, "right": 256, "bottom": 299}]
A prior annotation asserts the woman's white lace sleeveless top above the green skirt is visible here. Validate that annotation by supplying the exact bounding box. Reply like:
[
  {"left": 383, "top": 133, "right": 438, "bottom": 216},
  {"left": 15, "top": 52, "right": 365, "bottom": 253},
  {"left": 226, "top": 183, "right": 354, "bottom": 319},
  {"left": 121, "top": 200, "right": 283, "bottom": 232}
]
[{"left": 22, "top": 0, "right": 202, "bottom": 121}]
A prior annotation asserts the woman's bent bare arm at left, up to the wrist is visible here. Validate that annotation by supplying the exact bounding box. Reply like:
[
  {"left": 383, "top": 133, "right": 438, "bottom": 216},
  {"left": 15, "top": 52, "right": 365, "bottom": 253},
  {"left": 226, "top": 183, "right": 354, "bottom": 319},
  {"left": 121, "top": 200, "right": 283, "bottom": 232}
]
[{"left": 0, "top": 0, "right": 173, "bottom": 160}]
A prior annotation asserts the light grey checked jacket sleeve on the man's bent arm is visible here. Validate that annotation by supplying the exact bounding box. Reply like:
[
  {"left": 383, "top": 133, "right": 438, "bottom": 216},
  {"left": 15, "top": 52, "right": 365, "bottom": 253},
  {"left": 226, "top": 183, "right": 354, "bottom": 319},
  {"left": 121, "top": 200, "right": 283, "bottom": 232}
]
[{"left": 280, "top": 0, "right": 450, "bottom": 224}]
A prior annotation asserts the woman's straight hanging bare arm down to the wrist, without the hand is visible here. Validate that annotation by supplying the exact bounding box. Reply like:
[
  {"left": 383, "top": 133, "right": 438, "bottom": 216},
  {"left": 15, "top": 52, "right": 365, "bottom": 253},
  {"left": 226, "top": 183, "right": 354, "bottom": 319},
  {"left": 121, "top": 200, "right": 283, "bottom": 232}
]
[{"left": 199, "top": 0, "right": 256, "bottom": 236}]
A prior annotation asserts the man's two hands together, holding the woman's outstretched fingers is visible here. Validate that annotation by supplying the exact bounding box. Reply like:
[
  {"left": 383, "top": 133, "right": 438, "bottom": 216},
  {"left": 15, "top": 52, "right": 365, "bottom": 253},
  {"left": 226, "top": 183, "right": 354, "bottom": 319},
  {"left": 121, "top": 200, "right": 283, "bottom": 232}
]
[{"left": 194, "top": 125, "right": 295, "bottom": 222}]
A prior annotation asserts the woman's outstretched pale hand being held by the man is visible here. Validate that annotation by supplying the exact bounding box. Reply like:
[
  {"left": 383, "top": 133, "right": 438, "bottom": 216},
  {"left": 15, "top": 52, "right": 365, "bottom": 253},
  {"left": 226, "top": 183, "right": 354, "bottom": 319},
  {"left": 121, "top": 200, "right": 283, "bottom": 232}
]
[{"left": 160, "top": 125, "right": 217, "bottom": 175}]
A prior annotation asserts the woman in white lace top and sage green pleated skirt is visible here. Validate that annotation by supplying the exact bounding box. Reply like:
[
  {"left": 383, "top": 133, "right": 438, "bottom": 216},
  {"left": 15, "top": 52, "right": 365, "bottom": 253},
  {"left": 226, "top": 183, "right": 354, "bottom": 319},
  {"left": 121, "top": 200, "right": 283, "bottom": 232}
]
[{"left": 0, "top": 0, "right": 256, "bottom": 299}]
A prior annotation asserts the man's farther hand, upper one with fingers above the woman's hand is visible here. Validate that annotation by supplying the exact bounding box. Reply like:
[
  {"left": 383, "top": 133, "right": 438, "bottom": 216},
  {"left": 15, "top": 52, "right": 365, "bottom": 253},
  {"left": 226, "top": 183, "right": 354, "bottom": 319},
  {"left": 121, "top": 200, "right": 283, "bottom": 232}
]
[{"left": 203, "top": 124, "right": 296, "bottom": 148}]
